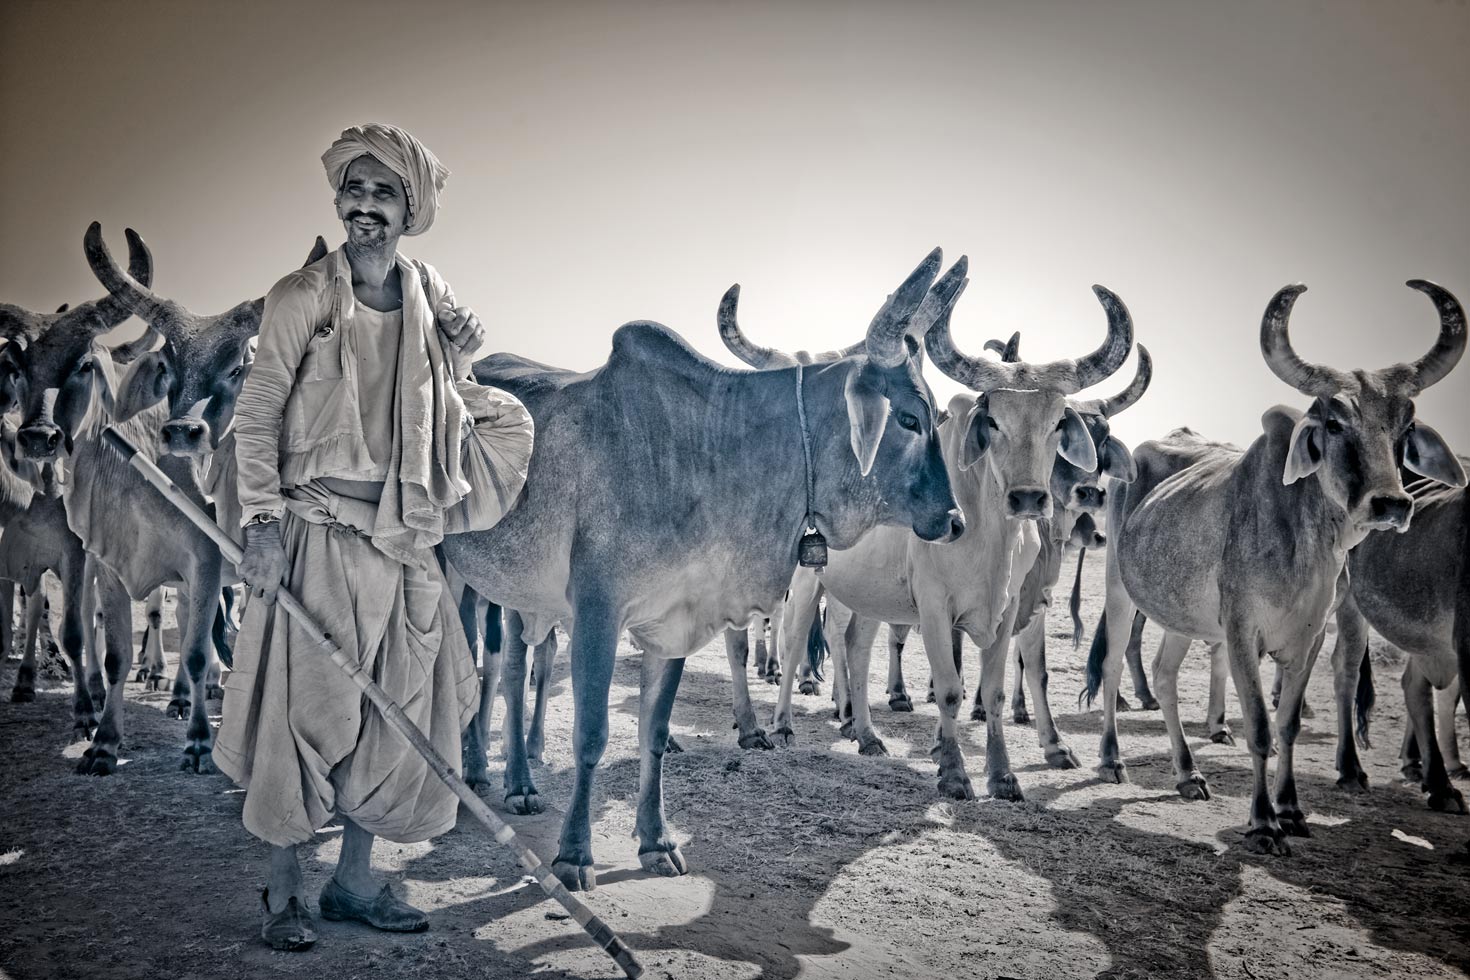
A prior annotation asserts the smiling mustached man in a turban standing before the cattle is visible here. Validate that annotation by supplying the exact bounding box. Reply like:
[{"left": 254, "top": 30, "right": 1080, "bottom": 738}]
[{"left": 215, "top": 123, "right": 531, "bottom": 951}]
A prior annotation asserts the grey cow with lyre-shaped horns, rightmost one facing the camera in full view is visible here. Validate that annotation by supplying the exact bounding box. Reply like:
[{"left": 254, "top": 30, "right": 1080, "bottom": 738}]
[{"left": 1089, "top": 279, "right": 1466, "bottom": 854}]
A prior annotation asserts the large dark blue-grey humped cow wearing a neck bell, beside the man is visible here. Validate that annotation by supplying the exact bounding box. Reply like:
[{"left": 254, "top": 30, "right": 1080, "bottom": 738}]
[{"left": 442, "top": 248, "right": 964, "bottom": 889}]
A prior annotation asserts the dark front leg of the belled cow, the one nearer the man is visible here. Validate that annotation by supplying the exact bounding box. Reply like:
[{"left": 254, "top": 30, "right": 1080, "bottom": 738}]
[{"left": 551, "top": 599, "right": 620, "bottom": 892}]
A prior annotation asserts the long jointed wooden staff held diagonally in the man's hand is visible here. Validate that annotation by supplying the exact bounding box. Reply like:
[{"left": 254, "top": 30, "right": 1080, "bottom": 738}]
[{"left": 101, "top": 426, "right": 642, "bottom": 980}]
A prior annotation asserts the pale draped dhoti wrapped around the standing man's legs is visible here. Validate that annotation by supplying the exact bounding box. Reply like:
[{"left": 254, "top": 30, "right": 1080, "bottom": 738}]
[{"left": 215, "top": 485, "right": 479, "bottom": 846}]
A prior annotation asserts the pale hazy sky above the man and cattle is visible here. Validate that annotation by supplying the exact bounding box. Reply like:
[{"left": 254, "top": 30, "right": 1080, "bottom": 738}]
[{"left": 0, "top": 0, "right": 1470, "bottom": 453}]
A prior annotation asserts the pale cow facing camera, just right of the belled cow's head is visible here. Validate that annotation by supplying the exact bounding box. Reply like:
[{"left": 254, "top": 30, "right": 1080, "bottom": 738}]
[{"left": 773, "top": 279, "right": 1133, "bottom": 799}]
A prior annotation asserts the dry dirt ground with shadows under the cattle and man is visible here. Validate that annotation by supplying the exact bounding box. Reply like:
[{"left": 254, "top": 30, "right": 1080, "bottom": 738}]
[{"left": 0, "top": 561, "right": 1470, "bottom": 980}]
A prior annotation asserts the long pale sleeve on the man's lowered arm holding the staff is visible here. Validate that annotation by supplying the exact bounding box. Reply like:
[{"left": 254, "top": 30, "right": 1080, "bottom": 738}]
[{"left": 235, "top": 272, "right": 319, "bottom": 526}]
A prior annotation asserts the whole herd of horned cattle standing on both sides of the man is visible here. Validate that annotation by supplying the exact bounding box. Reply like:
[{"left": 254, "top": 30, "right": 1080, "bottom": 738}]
[{"left": 0, "top": 223, "right": 1470, "bottom": 887}]
